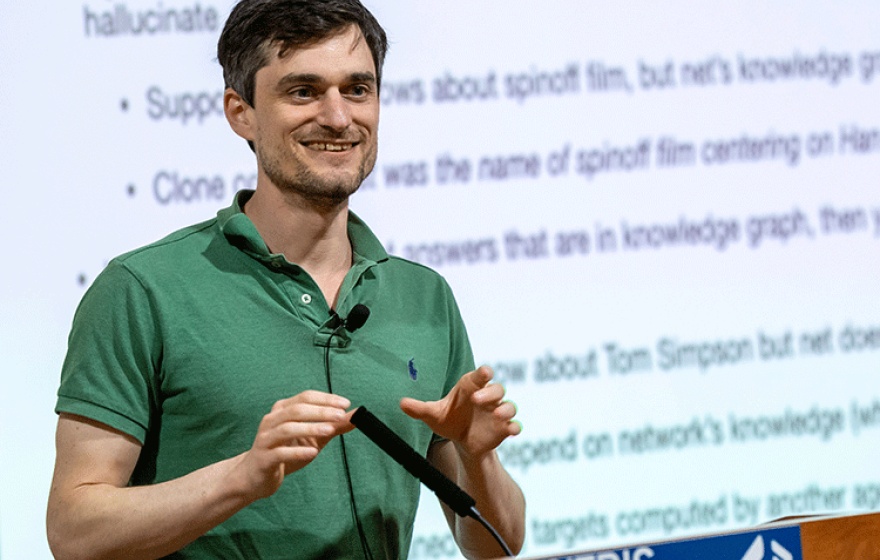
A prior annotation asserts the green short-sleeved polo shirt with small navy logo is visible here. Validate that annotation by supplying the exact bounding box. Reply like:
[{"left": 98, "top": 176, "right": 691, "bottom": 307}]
[{"left": 56, "top": 192, "right": 474, "bottom": 560}]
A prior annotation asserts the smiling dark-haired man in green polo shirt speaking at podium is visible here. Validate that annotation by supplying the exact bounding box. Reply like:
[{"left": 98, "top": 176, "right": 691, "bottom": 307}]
[{"left": 47, "top": 0, "right": 524, "bottom": 559}]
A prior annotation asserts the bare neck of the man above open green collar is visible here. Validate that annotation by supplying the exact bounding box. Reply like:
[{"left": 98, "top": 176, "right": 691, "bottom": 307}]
[{"left": 244, "top": 186, "right": 352, "bottom": 308}]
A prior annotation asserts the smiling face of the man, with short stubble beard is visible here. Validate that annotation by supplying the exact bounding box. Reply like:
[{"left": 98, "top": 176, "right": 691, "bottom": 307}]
[{"left": 246, "top": 26, "right": 379, "bottom": 204}]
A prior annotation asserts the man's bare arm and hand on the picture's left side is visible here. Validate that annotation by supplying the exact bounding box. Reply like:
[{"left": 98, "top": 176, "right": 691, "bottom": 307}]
[{"left": 46, "top": 391, "right": 354, "bottom": 560}]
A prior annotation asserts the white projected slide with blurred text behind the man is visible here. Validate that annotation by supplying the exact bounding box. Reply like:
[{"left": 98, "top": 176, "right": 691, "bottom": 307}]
[{"left": 0, "top": 0, "right": 880, "bottom": 559}]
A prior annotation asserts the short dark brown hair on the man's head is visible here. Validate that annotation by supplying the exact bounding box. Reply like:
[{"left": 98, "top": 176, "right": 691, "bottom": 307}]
[{"left": 217, "top": 0, "right": 388, "bottom": 107}]
